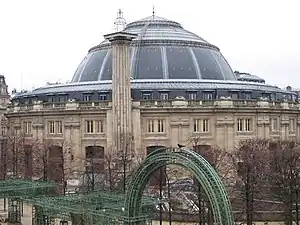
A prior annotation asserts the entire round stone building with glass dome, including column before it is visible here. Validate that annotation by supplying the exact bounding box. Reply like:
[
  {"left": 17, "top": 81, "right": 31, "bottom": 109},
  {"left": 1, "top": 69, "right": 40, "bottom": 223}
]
[{"left": 6, "top": 12, "right": 300, "bottom": 180}]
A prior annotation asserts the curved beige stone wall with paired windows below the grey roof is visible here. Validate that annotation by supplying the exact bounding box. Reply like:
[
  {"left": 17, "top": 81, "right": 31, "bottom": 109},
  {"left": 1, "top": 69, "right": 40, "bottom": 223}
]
[{"left": 6, "top": 99, "right": 300, "bottom": 171}]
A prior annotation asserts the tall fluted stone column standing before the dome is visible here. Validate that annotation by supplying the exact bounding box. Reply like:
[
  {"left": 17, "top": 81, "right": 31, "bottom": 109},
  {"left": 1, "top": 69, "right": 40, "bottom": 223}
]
[{"left": 104, "top": 31, "right": 137, "bottom": 151}]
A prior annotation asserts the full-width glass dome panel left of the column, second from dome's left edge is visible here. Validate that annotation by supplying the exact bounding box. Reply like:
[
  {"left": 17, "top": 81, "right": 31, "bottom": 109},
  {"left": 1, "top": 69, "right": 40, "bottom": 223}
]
[{"left": 81, "top": 51, "right": 106, "bottom": 82}]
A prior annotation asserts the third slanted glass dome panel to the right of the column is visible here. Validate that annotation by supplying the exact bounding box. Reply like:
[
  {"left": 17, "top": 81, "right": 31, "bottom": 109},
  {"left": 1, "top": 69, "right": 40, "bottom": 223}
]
[{"left": 193, "top": 48, "right": 224, "bottom": 80}]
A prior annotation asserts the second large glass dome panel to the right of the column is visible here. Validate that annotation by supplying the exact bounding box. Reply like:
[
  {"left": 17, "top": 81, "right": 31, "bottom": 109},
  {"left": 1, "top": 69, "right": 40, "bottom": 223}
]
[{"left": 167, "top": 48, "right": 198, "bottom": 79}]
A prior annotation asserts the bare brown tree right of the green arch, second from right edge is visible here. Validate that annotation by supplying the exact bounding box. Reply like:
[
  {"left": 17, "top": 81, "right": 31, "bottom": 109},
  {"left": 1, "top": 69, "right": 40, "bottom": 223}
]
[{"left": 234, "top": 139, "right": 269, "bottom": 225}]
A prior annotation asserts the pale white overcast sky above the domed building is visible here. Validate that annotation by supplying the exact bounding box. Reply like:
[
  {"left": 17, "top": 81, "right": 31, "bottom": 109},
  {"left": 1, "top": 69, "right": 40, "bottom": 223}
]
[{"left": 0, "top": 0, "right": 300, "bottom": 90}]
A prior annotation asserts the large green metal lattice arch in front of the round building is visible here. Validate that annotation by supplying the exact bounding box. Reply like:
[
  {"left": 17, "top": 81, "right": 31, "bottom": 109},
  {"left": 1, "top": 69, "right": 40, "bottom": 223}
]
[{"left": 125, "top": 148, "right": 234, "bottom": 225}]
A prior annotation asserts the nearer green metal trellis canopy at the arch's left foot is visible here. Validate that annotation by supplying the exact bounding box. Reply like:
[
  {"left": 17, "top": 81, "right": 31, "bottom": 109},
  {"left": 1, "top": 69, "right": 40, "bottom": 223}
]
[{"left": 24, "top": 191, "right": 160, "bottom": 225}]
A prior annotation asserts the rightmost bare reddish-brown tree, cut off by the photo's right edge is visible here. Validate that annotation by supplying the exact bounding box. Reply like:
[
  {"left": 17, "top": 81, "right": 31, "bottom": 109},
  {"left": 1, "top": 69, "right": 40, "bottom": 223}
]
[{"left": 269, "top": 141, "right": 300, "bottom": 225}]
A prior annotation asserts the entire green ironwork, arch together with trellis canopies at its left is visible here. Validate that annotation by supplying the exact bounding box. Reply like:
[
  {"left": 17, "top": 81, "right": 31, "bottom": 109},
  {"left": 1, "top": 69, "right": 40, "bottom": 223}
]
[{"left": 0, "top": 148, "right": 234, "bottom": 225}]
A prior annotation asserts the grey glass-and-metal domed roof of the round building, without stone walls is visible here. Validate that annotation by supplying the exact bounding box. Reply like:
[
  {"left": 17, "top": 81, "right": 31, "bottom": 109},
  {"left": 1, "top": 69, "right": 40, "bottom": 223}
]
[{"left": 12, "top": 12, "right": 298, "bottom": 105}]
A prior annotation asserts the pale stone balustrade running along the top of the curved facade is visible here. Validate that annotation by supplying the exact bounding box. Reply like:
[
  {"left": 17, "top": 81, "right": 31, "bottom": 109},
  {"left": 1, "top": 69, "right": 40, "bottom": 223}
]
[{"left": 8, "top": 99, "right": 300, "bottom": 112}]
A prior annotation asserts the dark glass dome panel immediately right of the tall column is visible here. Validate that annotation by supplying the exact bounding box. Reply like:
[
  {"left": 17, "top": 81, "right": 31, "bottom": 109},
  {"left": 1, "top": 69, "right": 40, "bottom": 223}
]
[{"left": 133, "top": 48, "right": 163, "bottom": 79}]
